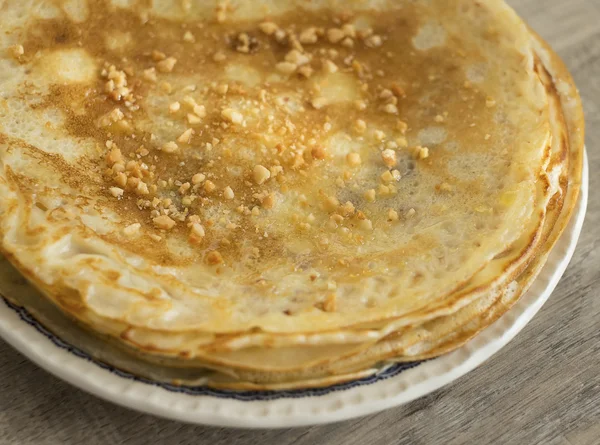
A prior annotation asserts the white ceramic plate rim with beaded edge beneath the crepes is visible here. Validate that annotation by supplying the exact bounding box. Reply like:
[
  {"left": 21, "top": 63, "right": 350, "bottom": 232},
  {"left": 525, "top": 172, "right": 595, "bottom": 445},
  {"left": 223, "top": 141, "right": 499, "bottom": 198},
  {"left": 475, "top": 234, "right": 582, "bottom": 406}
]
[{"left": 0, "top": 152, "right": 588, "bottom": 428}]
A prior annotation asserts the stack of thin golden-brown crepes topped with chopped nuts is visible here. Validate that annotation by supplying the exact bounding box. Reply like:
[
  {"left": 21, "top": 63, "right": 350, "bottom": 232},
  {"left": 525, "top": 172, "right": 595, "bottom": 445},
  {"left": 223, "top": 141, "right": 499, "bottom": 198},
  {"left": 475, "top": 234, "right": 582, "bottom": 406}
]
[{"left": 0, "top": 0, "right": 583, "bottom": 389}]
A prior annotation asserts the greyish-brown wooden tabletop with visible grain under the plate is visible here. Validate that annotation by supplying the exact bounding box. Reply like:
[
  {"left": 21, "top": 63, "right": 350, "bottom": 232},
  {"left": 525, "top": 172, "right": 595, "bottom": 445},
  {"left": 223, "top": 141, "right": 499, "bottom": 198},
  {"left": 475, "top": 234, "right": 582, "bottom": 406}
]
[{"left": 0, "top": 0, "right": 600, "bottom": 445}]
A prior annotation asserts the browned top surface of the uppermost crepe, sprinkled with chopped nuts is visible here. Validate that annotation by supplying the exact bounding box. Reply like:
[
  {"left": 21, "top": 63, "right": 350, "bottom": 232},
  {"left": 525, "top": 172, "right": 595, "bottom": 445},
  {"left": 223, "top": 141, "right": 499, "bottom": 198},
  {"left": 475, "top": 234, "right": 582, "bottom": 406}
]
[{"left": 1, "top": 2, "right": 548, "bottom": 331}]
